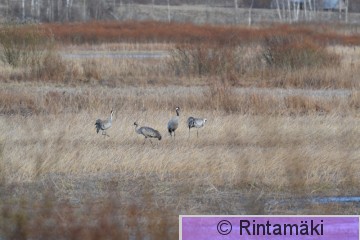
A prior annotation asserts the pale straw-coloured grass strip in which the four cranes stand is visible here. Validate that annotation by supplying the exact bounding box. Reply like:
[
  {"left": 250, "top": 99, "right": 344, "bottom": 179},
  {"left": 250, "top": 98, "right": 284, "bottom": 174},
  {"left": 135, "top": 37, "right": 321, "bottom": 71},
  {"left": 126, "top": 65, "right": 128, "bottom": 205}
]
[{"left": 1, "top": 110, "right": 360, "bottom": 199}]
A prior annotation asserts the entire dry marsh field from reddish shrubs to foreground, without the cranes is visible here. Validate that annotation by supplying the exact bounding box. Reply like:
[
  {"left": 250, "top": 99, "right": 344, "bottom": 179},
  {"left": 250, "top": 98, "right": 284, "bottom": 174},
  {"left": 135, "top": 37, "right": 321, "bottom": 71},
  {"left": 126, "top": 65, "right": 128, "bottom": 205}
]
[{"left": 0, "top": 23, "right": 360, "bottom": 239}]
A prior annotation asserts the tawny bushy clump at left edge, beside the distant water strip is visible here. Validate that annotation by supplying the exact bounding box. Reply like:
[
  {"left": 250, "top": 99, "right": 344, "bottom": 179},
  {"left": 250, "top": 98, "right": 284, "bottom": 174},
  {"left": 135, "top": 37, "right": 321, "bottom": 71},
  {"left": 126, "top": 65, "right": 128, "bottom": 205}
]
[{"left": 0, "top": 25, "right": 65, "bottom": 80}]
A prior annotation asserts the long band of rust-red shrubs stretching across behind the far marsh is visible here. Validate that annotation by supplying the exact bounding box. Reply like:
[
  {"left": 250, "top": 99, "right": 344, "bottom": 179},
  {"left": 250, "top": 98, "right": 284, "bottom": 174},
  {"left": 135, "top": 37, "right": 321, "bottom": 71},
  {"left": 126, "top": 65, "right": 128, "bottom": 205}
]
[{"left": 37, "top": 21, "right": 360, "bottom": 45}]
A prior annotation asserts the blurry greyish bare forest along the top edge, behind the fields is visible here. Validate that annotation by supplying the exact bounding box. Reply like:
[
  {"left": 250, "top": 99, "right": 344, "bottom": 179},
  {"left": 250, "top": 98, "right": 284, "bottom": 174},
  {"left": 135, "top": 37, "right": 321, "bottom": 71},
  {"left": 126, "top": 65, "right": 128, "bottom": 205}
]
[{"left": 0, "top": 0, "right": 360, "bottom": 22}]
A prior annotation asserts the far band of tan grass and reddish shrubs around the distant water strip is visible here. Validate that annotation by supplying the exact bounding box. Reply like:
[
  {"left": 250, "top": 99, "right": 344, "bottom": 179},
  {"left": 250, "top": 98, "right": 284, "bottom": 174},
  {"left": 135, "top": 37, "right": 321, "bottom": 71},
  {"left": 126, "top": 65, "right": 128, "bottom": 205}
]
[{"left": 2, "top": 22, "right": 359, "bottom": 89}]
